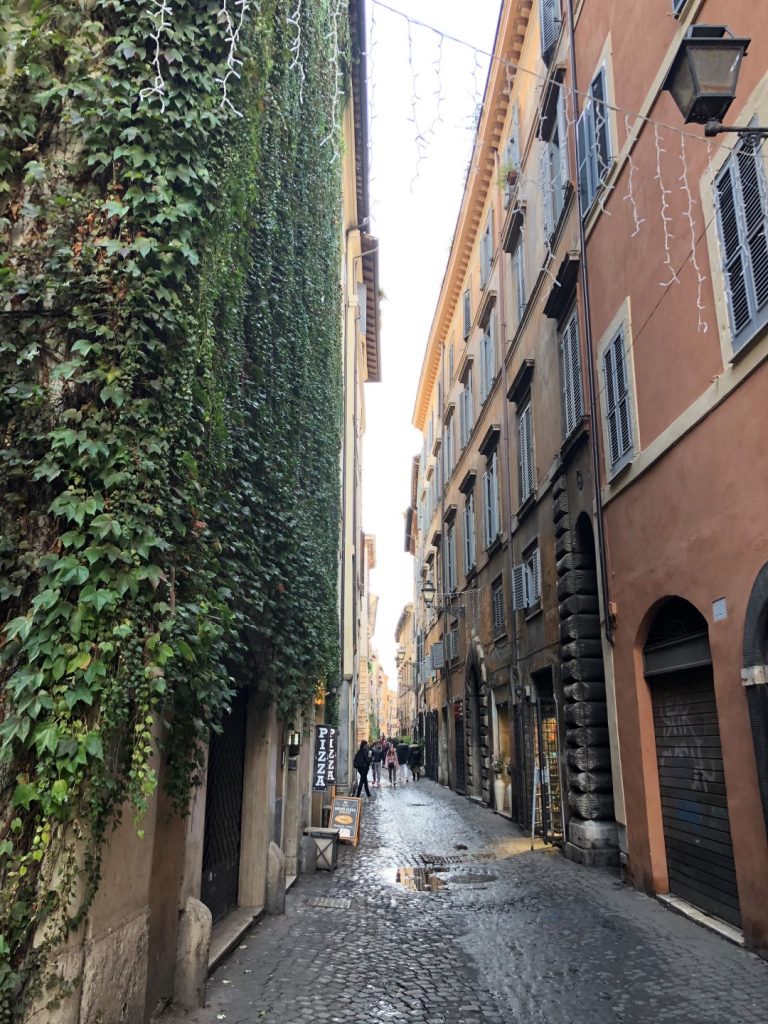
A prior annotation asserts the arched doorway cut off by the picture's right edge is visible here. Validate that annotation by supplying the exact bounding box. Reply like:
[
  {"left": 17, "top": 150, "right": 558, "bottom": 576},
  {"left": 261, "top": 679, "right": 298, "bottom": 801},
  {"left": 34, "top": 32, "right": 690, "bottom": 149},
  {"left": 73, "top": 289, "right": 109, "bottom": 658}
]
[{"left": 742, "top": 564, "right": 768, "bottom": 830}]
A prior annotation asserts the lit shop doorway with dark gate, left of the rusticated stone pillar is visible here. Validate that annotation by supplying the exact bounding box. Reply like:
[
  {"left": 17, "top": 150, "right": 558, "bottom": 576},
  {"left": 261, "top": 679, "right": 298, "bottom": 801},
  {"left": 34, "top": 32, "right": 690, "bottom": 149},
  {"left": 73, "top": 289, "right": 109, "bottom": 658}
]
[{"left": 513, "top": 700, "right": 563, "bottom": 843}]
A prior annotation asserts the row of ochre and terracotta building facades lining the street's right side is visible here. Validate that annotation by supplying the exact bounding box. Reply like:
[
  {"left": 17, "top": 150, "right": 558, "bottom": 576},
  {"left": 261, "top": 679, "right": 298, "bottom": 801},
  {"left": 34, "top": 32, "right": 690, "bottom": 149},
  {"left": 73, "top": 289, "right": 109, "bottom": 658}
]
[{"left": 406, "top": 0, "right": 768, "bottom": 951}]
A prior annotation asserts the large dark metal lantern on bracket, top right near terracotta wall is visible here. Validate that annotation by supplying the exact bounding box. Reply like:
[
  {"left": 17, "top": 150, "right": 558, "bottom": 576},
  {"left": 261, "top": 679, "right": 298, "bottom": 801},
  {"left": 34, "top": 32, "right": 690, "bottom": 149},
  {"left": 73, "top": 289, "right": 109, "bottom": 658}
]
[{"left": 664, "top": 25, "right": 768, "bottom": 136}]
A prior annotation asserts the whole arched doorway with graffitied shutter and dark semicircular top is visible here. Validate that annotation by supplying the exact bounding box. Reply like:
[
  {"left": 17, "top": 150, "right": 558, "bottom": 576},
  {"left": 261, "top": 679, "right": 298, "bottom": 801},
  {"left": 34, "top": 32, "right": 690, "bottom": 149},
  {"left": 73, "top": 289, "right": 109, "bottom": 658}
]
[{"left": 643, "top": 597, "right": 740, "bottom": 926}]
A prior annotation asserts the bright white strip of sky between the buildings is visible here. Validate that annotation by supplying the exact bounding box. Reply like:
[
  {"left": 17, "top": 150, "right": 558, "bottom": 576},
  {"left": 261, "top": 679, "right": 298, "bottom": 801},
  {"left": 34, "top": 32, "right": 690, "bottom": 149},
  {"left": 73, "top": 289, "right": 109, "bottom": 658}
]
[{"left": 362, "top": 0, "right": 500, "bottom": 686}]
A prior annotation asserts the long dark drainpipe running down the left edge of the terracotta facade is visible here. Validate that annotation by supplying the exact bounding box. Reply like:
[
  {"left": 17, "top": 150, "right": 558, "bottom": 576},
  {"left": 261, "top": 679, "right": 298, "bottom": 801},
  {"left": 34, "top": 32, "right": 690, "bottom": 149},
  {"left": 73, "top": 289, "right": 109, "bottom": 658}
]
[{"left": 568, "top": 0, "right": 613, "bottom": 644}]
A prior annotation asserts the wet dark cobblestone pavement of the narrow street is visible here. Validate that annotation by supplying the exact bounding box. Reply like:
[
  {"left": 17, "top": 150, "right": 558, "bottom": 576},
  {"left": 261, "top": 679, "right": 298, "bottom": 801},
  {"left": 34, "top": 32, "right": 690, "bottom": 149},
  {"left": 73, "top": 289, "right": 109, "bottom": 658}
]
[{"left": 161, "top": 780, "right": 768, "bottom": 1024}]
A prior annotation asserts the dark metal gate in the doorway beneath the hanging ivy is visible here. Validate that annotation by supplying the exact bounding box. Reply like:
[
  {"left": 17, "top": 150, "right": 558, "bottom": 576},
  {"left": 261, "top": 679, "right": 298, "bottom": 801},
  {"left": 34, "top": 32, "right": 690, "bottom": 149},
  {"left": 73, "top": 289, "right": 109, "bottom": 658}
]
[{"left": 200, "top": 692, "right": 248, "bottom": 923}]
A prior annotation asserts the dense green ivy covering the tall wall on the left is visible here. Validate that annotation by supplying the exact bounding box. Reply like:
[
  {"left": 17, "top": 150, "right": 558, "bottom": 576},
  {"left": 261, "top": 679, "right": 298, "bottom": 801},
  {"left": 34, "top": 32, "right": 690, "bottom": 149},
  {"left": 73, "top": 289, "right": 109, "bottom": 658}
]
[{"left": 0, "top": 0, "right": 346, "bottom": 1007}]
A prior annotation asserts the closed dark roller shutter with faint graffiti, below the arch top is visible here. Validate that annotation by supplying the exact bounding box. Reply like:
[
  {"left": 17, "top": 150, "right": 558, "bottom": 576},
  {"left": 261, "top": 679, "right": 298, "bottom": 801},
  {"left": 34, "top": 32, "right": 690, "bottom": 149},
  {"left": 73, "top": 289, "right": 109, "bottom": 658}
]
[{"left": 651, "top": 668, "right": 741, "bottom": 927}]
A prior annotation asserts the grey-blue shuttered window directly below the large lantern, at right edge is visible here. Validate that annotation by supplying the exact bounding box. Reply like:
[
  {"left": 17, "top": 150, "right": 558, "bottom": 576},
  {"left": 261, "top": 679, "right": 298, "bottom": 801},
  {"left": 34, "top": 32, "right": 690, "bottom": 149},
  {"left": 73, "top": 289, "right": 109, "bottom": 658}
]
[{"left": 715, "top": 138, "right": 768, "bottom": 351}]
